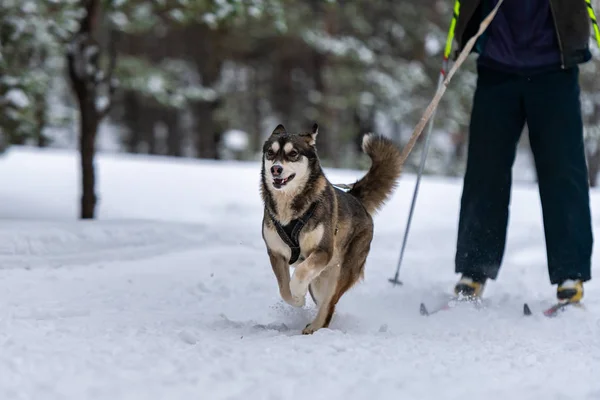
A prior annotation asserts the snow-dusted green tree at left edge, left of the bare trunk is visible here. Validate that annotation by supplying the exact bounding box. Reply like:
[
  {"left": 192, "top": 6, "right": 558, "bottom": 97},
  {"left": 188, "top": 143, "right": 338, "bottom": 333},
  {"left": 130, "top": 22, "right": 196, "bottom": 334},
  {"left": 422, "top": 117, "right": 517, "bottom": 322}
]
[{"left": 0, "top": 0, "right": 80, "bottom": 149}]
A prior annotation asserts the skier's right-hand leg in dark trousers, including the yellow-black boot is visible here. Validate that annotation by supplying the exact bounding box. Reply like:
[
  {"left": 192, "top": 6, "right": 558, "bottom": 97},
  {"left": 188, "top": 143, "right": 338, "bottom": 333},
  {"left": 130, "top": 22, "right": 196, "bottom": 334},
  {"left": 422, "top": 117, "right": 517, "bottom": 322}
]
[{"left": 525, "top": 68, "right": 593, "bottom": 300}]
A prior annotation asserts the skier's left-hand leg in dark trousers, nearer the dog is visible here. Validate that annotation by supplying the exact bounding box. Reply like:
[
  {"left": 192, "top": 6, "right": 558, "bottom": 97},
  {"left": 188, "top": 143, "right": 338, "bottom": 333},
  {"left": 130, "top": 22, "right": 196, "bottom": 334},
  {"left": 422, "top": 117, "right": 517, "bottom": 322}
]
[{"left": 455, "top": 67, "right": 525, "bottom": 291}]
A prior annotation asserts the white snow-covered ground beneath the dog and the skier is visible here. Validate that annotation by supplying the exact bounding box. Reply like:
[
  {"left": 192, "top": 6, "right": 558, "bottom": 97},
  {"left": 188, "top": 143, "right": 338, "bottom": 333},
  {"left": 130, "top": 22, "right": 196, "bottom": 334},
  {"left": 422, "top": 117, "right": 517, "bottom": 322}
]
[{"left": 0, "top": 148, "right": 600, "bottom": 400}]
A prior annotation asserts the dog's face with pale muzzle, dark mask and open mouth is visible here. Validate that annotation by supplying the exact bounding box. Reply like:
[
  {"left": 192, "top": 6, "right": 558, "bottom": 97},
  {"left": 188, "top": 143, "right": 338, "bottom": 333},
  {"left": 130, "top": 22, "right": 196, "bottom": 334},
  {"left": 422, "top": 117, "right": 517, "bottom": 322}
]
[{"left": 263, "top": 124, "right": 318, "bottom": 192}]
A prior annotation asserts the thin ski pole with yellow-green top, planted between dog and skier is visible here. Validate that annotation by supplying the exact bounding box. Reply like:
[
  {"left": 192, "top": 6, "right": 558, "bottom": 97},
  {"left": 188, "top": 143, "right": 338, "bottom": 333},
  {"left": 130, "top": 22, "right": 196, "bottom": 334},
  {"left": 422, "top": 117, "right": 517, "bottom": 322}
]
[{"left": 389, "top": 0, "right": 460, "bottom": 286}]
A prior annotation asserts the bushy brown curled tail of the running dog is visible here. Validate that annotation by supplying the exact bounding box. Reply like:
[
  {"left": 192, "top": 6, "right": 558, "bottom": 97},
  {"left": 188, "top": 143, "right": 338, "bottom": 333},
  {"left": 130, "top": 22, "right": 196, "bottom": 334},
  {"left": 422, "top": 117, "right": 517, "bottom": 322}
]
[{"left": 348, "top": 133, "right": 402, "bottom": 215}]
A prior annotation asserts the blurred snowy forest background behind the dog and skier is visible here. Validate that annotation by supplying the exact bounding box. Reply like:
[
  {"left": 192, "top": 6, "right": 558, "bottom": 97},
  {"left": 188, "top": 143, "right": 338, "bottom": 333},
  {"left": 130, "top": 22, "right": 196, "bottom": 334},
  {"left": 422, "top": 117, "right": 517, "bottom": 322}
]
[{"left": 0, "top": 0, "right": 600, "bottom": 214}]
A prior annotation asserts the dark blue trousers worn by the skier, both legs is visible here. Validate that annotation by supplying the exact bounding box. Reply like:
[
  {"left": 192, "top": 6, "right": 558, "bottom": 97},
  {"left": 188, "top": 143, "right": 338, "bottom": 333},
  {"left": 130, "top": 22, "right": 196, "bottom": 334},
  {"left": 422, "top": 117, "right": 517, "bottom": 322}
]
[{"left": 455, "top": 66, "right": 593, "bottom": 284}]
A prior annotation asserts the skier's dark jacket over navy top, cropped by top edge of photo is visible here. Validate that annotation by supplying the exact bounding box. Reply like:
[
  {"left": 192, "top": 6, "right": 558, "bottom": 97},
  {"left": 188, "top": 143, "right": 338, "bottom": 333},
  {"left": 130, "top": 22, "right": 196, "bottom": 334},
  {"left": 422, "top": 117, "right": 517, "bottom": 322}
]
[{"left": 455, "top": 0, "right": 591, "bottom": 71}]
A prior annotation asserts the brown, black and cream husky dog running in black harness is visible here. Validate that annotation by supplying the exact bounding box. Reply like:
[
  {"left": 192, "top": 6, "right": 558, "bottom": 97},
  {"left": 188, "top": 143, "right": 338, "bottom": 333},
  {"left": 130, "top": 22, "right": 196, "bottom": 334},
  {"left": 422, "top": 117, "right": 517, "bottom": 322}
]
[{"left": 260, "top": 124, "right": 402, "bottom": 334}]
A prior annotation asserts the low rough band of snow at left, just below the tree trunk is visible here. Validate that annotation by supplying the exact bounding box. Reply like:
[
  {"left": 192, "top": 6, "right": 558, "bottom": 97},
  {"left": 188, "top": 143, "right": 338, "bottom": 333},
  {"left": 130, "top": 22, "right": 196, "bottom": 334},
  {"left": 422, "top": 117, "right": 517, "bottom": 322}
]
[{"left": 0, "top": 221, "right": 210, "bottom": 269}]
